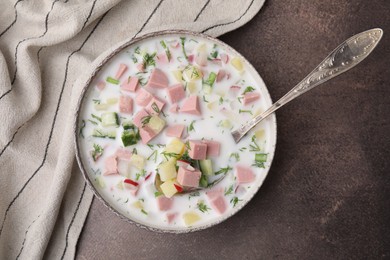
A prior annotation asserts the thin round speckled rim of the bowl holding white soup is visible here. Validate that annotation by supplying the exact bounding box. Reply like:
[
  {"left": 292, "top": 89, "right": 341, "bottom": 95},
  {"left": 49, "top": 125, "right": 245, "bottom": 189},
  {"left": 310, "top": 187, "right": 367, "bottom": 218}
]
[{"left": 73, "top": 30, "right": 277, "bottom": 234}]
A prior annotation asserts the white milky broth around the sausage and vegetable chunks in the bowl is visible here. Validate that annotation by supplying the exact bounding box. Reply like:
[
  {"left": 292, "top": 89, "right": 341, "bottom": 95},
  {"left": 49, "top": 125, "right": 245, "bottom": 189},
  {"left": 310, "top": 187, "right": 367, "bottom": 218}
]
[{"left": 79, "top": 35, "right": 275, "bottom": 230}]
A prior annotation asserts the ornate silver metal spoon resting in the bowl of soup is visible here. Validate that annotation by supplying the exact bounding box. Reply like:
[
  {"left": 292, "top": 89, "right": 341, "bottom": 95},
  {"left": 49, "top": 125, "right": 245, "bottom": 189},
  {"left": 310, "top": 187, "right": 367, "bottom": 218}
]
[{"left": 232, "top": 28, "right": 383, "bottom": 143}]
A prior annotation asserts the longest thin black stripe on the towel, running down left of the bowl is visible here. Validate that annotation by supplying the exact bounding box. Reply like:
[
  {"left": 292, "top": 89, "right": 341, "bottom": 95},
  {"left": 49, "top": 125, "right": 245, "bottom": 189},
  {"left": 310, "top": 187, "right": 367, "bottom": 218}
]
[{"left": 0, "top": 10, "right": 110, "bottom": 236}]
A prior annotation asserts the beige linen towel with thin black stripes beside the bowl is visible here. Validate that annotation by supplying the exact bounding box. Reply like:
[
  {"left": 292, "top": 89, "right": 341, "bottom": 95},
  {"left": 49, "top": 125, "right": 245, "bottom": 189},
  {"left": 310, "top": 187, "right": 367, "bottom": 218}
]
[{"left": 0, "top": 0, "right": 264, "bottom": 259}]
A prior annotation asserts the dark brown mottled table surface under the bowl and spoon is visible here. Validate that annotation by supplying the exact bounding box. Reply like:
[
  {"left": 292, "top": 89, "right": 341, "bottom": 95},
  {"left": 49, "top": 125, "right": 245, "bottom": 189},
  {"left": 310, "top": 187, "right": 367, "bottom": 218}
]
[{"left": 76, "top": 0, "right": 390, "bottom": 259}]
